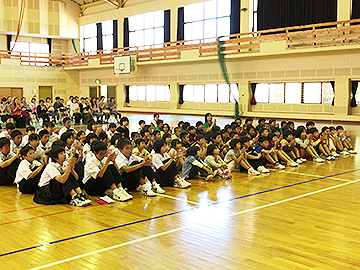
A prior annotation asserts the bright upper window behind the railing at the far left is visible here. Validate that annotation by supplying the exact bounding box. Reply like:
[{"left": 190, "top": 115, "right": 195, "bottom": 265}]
[{"left": 10, "top": 41, "right": 49, "bottom": 66}]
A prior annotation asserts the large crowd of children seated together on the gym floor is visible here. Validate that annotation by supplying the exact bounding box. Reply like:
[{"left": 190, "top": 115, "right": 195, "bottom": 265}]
[{"left": 0, "top": 113, "right": 356, "bottom": 206}]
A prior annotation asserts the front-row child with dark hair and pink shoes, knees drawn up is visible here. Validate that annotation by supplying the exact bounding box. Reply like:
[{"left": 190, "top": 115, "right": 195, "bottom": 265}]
[{"left": 204, "top": 144, "right": 232, "bottom": 179}]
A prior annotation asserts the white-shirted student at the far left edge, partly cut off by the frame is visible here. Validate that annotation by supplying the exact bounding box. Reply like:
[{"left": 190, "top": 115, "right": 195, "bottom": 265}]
[{"left": 0, "top": 138, "right": 20, "bottom": 186}]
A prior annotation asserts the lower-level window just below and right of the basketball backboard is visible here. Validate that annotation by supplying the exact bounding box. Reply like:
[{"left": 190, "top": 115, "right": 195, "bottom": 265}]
[{"left": 129, "top": 85, "right": 171, "bottom": 101}]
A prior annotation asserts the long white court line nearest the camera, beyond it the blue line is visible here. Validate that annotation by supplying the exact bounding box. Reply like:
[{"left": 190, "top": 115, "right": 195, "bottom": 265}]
[{"left": 30, "top": 179, "right": 360, "bottom": 270}]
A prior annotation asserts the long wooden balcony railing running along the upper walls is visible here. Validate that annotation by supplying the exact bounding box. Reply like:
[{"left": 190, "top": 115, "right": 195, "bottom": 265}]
[{"left": 0, "top": 19, "right": 360, "bottom": 67}]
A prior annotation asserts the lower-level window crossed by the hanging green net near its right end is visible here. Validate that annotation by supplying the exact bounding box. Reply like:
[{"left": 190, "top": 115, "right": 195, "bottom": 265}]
[{"left": 183, "top": 84, "right": 239, "bottom": 103}]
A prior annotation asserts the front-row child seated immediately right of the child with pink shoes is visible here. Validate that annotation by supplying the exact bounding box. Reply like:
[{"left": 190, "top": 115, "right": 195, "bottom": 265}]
[{"left": 224, "top": 139, "right": 260, "bottom": 175}]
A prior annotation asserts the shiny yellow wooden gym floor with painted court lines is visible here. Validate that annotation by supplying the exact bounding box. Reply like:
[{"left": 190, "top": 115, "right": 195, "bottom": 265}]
[{"left": 0, "top": 115, "right": 360, "bottom": 269}]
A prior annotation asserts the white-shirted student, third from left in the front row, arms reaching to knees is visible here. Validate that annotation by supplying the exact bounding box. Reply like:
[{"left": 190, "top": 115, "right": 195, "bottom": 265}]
[{"left": 115, "top": 139, "right": 165, "bottom": 194}]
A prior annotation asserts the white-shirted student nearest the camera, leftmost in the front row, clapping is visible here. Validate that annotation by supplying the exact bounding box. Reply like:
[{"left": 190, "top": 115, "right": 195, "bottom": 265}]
[{"left": 34, "top": 146, "right": 91, "bottom": 206}]
